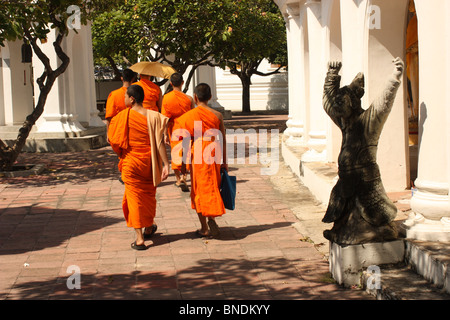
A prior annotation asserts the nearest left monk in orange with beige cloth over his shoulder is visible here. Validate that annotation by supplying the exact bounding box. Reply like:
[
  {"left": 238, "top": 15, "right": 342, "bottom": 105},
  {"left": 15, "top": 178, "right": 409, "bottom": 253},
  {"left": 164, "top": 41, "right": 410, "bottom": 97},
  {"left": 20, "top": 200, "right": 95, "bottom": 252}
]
[{"left": 109, "top": 85, "right": 169, "bottom": 250}]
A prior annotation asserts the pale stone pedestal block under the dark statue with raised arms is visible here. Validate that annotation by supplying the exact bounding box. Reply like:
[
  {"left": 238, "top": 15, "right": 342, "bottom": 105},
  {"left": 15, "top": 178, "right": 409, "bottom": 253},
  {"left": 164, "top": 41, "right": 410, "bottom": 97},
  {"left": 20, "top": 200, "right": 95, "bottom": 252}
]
[{"left": 330, "top": 240, "right": 405, "bottom": 287}]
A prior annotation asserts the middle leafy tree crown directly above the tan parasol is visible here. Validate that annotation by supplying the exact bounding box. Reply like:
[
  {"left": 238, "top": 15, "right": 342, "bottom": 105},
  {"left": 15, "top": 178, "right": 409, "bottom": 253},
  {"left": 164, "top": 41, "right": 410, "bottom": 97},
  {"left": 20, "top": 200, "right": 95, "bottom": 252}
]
[{"left": 142, "top": 0, "right": 231, "bottom": 90}]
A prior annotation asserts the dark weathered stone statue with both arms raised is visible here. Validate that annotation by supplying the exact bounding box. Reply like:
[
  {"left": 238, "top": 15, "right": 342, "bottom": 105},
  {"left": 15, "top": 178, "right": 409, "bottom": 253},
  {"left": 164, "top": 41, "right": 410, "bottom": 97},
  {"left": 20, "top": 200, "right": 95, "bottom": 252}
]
[{"left": 322, "top": 58, "right": 404, "bottom": 245}]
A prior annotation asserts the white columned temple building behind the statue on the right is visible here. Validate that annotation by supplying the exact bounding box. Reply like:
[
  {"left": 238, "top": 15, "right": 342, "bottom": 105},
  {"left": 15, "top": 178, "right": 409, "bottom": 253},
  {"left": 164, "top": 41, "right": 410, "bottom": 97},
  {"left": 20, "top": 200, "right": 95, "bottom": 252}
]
[{"left": 275, "top": 0, "right": 450, "bottom": 241}]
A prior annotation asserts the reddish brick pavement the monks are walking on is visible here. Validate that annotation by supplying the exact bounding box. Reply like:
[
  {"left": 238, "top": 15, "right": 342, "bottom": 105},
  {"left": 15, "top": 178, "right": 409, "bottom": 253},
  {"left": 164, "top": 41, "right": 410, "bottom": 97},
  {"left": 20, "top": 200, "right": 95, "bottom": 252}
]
[{"left": 0, "top": 139, "right": 372, "bottom": 300}]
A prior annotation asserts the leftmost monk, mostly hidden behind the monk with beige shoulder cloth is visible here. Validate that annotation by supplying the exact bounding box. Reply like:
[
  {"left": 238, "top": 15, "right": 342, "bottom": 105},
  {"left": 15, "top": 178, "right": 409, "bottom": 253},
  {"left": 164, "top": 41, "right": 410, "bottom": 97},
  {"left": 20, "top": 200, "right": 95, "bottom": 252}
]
[{"left": 105, "top": 69, "right": 137, "bottom": 140}]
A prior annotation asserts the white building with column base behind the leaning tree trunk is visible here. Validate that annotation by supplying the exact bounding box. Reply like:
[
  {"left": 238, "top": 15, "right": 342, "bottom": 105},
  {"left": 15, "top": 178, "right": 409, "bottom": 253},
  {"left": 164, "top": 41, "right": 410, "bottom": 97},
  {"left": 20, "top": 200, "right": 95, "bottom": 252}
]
[{"left": 0, "top": 25, "right": 106, "bottom": 151}]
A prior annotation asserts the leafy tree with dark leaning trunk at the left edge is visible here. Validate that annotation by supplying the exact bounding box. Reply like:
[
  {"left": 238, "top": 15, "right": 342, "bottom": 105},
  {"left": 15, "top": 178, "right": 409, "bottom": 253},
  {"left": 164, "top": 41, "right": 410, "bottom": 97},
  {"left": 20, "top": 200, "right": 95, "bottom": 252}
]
[{"left": 0, "top": 0, "right": 114, "bottom": 171}]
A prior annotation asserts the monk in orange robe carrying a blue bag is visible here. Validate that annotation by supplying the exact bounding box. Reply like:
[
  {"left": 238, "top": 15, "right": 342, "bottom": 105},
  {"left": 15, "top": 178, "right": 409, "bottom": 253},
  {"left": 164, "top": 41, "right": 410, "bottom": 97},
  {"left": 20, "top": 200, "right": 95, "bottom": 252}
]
[{"left": 172, "top": 83, "right": 228, "bottom": 237}]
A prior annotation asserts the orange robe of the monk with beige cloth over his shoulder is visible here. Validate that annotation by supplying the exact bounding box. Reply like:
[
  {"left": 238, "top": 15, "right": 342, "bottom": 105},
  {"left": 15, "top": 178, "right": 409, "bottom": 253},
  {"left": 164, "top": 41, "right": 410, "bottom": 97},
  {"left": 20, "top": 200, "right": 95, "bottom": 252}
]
[{"left": 108, "top": 108, "right": 156, "bottom": 228}]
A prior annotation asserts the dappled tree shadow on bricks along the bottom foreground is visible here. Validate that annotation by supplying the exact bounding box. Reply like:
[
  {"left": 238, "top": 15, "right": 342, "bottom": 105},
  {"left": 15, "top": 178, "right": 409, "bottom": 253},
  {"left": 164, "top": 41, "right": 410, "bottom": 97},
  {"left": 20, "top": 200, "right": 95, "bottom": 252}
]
[{"left": 7, "top": 257, "right": 356, "bottom": 300}]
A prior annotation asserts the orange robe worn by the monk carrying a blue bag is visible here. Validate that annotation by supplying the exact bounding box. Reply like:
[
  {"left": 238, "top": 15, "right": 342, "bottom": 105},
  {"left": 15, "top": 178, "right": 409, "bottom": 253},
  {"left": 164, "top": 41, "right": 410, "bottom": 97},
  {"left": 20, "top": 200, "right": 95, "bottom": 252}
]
[{"left": 174, "top": 106, "right": 225, "bottom": 217}]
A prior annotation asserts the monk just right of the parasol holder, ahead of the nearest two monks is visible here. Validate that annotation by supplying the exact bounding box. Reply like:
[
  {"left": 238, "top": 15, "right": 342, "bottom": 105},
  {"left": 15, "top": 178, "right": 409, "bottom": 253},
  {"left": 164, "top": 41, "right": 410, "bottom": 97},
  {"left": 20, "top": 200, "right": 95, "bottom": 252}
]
[{"left": 161, "top": 72, "right": 195, "bottom": 191}]
